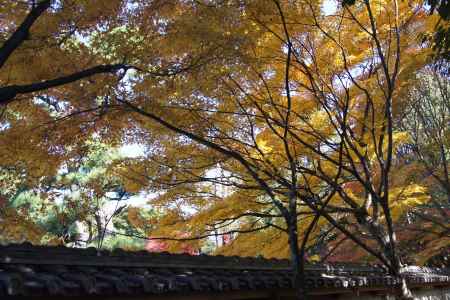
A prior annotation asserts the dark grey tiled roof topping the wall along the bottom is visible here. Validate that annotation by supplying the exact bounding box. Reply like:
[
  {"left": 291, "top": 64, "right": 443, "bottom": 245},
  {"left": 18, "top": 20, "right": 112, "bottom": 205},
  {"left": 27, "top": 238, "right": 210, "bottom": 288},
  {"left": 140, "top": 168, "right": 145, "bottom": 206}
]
[{"left": 0, "top": 244, "right": 450, "bottom": 297}]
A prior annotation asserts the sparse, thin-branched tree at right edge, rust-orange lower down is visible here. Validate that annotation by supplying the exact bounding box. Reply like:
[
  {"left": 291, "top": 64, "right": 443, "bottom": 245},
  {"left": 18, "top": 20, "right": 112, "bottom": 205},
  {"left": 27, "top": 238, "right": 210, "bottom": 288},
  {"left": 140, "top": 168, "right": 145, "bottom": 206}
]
[{"left": 399, "top": 66, "right": 450, "bottom": 263}]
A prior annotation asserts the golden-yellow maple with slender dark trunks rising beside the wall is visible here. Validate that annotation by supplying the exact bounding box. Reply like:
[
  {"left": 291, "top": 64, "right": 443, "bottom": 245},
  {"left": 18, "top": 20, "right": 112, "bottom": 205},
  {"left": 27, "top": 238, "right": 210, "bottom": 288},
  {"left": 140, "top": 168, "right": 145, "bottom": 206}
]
[{"left": 110, "top": 1, "right": 442, "bottom": 294}]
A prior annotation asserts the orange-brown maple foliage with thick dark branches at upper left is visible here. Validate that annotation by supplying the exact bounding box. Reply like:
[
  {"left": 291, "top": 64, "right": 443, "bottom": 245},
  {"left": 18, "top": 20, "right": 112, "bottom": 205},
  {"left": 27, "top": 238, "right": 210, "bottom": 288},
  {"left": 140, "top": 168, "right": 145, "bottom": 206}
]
[{"left": 0, "top": 0, "right": 211, "bottom": 186}]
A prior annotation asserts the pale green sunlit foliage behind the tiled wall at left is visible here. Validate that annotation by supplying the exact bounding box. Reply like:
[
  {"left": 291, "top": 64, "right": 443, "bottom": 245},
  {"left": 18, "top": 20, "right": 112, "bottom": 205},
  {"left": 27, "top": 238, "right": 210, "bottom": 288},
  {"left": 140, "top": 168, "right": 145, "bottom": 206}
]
[{"left": 0, "top": 141, "right": 138, "bottom": 244}]
